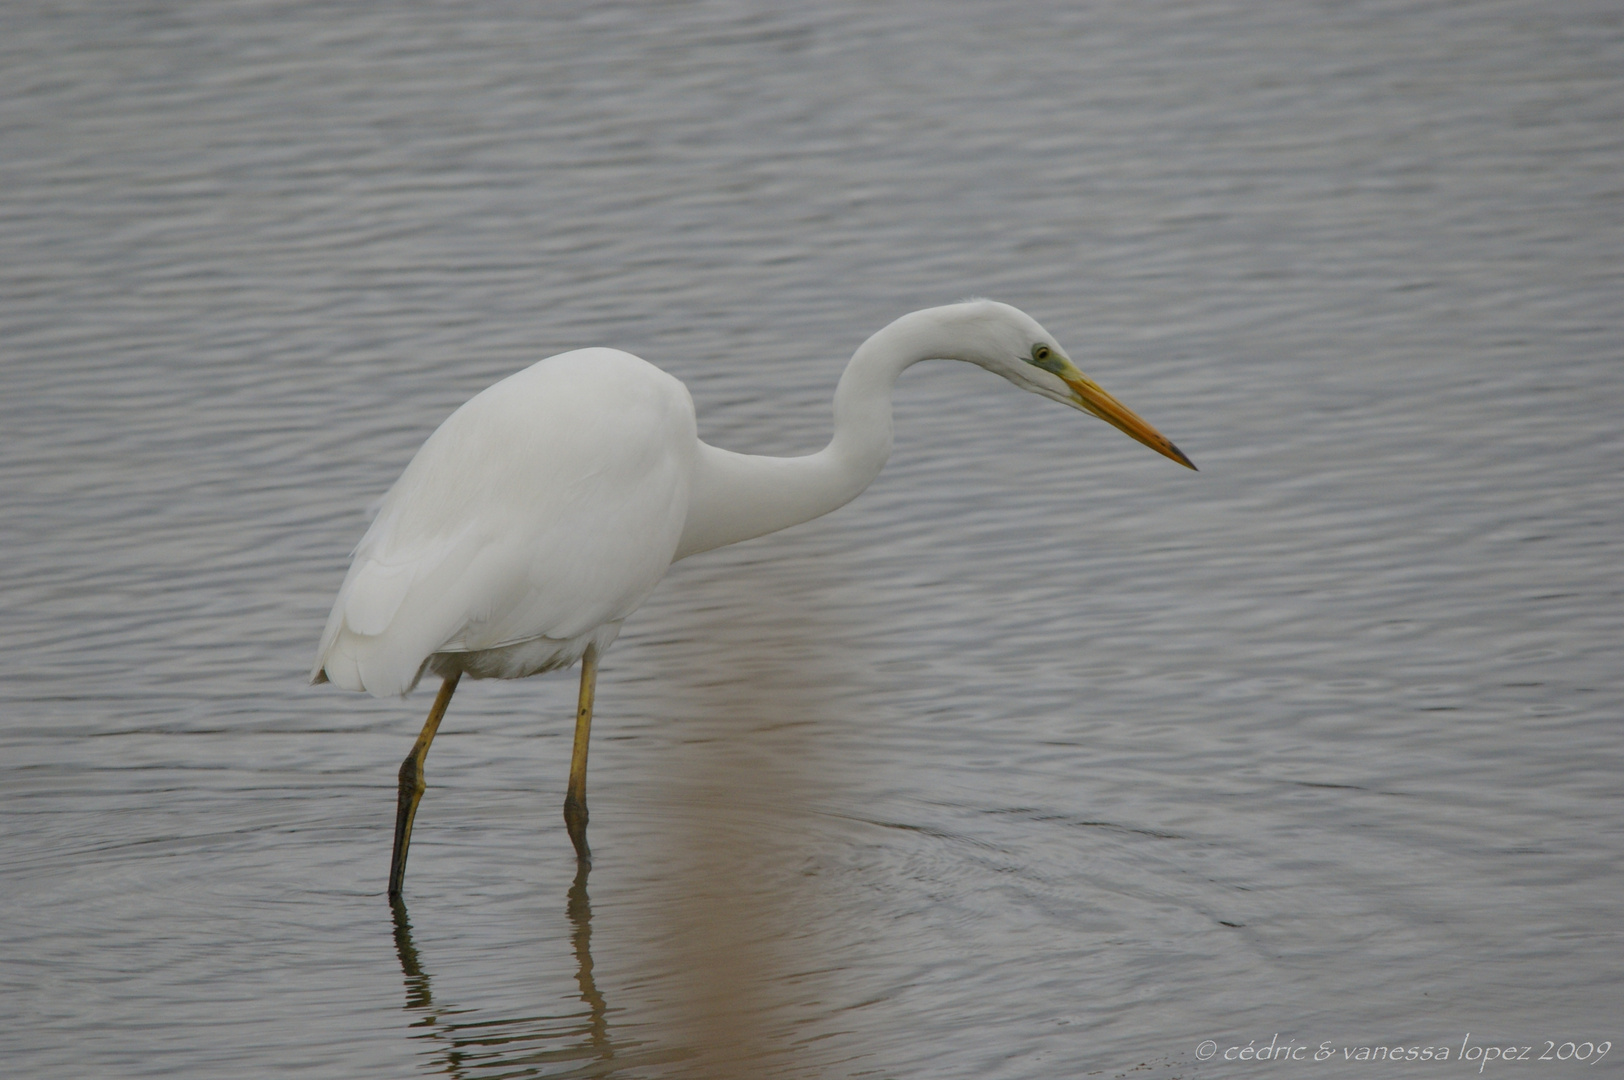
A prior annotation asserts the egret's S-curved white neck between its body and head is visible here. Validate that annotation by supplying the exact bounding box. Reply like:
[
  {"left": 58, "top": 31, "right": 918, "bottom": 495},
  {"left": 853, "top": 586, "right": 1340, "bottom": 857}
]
[{"left": 676, "top": 312, "right": 953, "bottom": 559}]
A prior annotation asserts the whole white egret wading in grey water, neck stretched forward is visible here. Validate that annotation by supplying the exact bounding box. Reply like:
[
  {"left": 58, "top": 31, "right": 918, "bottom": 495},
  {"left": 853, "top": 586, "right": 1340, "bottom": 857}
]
[{"left": 310, "top": 300, "right": 1195, "bottom": 898}]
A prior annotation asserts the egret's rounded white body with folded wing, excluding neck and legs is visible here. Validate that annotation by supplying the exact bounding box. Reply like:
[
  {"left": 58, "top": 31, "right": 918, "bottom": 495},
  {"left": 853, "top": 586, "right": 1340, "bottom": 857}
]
[{"left": 312, "top": 349, "right": 698, "bottom": 697}]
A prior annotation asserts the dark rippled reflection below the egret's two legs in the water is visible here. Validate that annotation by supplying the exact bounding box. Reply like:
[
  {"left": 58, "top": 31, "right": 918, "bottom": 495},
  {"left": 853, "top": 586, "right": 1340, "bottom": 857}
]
[{"left": 391, "top": 862, "right": 649, "bottom": 1078}]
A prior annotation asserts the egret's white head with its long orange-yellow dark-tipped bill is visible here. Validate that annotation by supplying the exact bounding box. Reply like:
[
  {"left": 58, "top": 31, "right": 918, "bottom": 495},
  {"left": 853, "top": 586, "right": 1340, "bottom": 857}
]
[{"left": 934, "top": 300, "right": 1195, "bottom": 469}]
